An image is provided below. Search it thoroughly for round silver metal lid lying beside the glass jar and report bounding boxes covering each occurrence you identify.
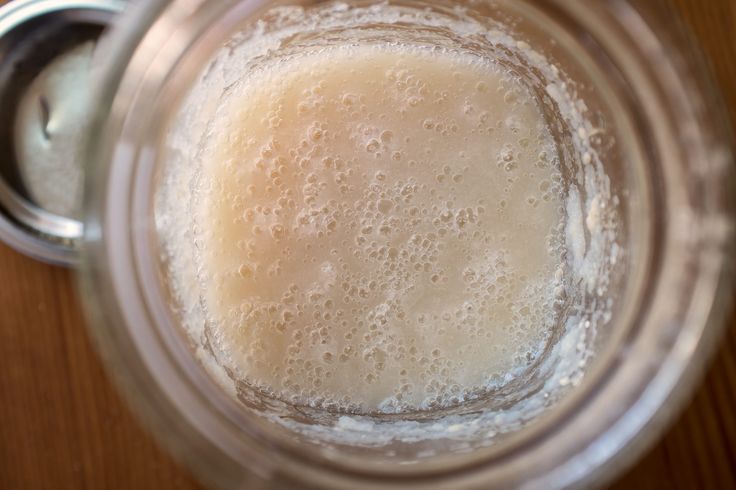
[0,0,125,266]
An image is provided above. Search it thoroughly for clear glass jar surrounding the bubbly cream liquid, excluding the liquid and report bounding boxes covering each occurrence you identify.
[77,0,733,489]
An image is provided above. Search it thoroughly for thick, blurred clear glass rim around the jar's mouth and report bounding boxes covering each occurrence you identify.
[77,2,732,488]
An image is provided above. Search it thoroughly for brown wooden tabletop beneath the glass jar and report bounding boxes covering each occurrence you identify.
[0,0,736,490]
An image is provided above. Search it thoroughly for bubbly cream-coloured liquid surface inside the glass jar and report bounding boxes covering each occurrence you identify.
[194,46,563,411]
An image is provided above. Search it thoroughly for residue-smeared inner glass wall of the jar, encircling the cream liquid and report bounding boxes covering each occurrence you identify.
[142,1,656,472]
